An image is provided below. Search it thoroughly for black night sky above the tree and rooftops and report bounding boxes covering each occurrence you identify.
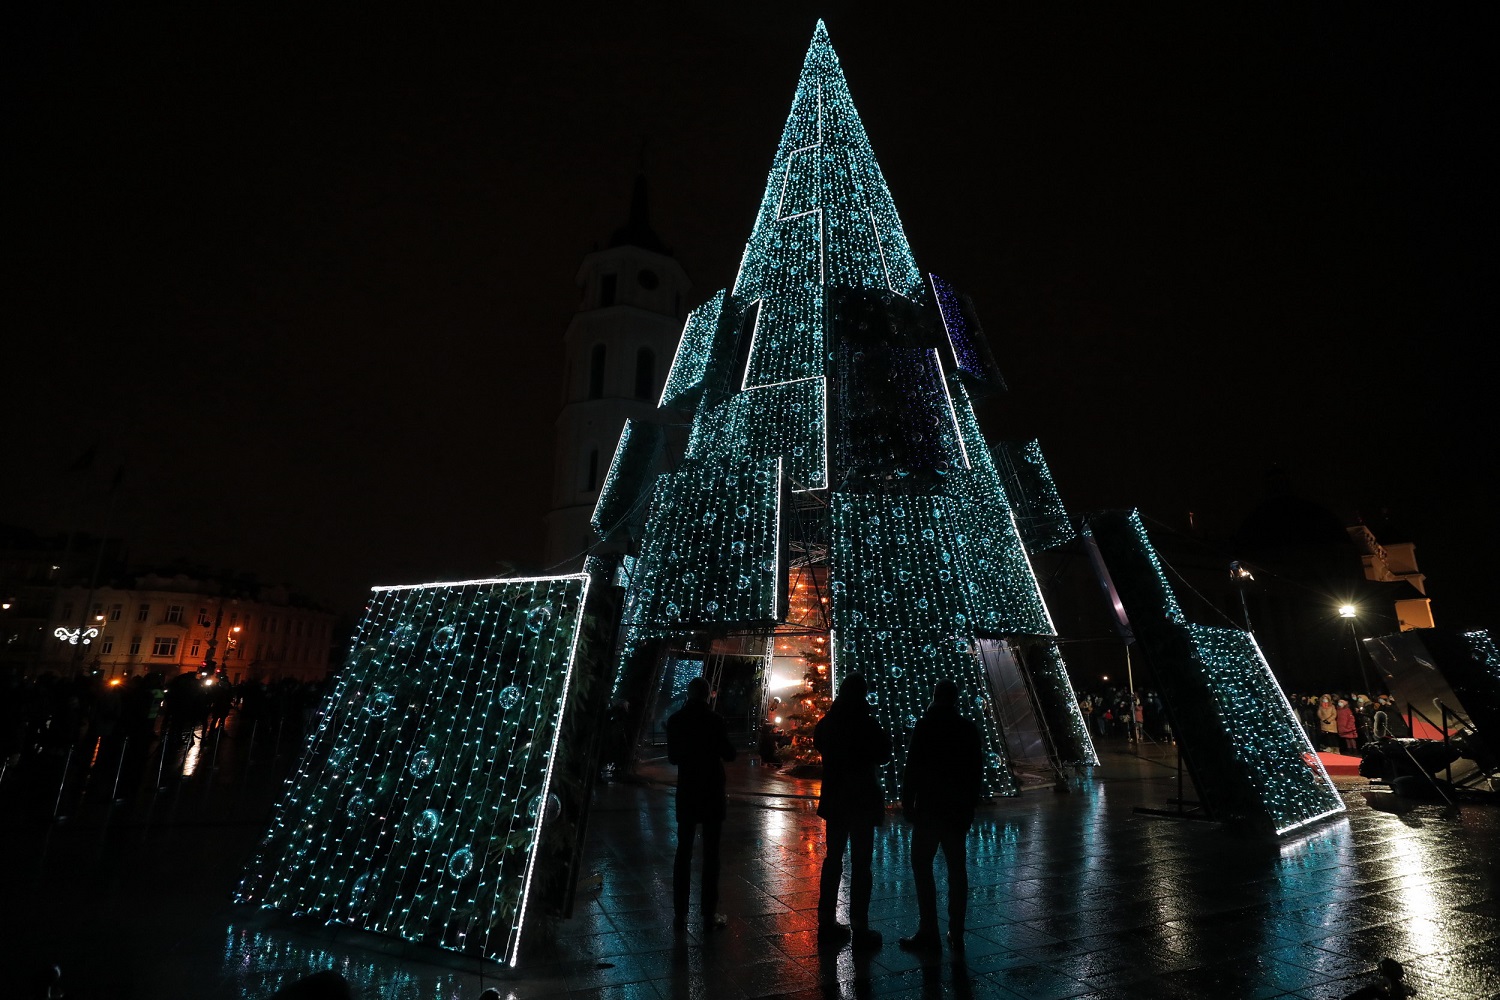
[0,3,1497,625]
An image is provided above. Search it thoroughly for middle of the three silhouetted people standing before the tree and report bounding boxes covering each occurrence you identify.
[813,673,891,951]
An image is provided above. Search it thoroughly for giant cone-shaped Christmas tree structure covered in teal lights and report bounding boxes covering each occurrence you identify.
[594,22,1095,798]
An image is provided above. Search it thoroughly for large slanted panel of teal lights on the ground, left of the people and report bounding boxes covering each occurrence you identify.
[236,576,588,966]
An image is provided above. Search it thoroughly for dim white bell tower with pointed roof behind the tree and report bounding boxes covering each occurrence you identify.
[543,175,690,573]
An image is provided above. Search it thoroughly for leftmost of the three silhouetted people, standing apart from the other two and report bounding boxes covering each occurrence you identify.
[666,678,735,931]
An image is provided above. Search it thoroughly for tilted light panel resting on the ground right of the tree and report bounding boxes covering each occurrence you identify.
[1086,511,1344,835]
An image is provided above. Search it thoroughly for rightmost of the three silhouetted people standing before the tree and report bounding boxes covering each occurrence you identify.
[900,681,984,951]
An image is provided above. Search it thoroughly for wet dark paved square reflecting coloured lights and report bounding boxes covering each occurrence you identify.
[0,728,1500,1000]
